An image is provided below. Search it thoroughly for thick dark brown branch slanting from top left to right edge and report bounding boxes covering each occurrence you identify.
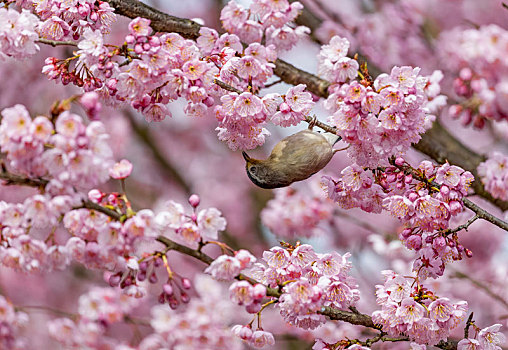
[107,0,508,211]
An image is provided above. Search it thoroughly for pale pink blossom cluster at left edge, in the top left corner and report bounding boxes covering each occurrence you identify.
[0,8,39,60]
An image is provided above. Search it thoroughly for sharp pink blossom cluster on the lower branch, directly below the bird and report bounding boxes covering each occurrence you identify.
[251,244,360,329]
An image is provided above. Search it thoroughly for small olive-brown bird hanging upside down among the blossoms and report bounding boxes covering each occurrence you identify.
[242,127,340,189]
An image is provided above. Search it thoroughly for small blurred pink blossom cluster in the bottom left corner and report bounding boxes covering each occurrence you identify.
[0,295,28,350]
